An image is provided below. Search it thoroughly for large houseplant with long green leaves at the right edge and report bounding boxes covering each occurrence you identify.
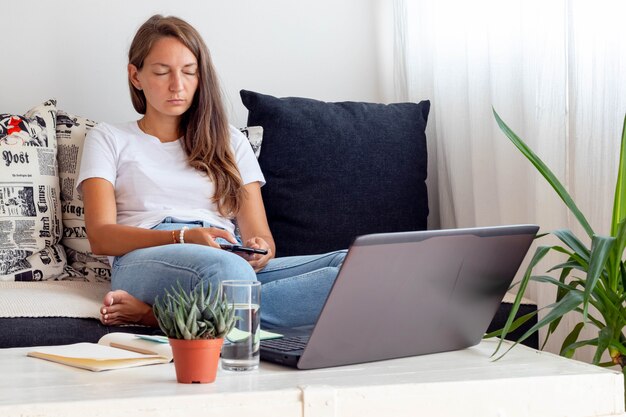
[490,110,626,375]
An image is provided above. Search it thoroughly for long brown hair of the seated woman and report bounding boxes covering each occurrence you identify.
[128,15,244,217]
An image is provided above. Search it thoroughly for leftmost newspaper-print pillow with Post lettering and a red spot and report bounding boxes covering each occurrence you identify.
[0,100,67,281]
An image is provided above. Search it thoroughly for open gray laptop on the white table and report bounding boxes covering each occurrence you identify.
[261,225,539,369]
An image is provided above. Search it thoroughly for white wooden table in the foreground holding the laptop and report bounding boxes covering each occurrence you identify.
[0,341,626,417]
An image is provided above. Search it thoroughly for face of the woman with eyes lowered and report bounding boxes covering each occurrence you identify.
[128,37,198,118]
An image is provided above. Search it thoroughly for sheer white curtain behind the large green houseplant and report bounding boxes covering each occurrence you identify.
[390,0,626,359]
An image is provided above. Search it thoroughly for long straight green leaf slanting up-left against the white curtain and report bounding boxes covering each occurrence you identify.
[492,109,594,237]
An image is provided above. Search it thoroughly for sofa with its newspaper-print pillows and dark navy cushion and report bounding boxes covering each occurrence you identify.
[0,90,538,348]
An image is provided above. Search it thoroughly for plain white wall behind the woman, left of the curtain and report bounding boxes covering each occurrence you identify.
[0,0,382,126]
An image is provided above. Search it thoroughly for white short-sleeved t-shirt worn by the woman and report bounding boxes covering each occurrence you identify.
[76,121,265,233]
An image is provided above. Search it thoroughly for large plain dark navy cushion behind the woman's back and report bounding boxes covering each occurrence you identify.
[241,90,430,256]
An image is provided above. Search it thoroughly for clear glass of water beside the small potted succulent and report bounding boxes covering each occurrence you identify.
[222,281,261,371]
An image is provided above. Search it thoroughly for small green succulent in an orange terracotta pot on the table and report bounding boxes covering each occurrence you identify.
[153,283,235,384]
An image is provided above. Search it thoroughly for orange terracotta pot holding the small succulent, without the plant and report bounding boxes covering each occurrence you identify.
[170,338,224,384]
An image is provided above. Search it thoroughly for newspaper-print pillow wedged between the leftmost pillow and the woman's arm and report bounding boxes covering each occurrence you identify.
[56,110,111,281]
